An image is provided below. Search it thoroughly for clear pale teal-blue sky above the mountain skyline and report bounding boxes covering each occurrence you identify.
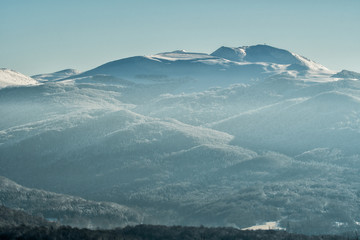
[0,0,360,75]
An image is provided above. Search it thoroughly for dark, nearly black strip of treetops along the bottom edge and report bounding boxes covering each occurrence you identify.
[0,225,357,240]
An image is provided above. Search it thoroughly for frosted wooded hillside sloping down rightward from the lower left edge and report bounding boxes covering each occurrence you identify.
[0,177,141,228]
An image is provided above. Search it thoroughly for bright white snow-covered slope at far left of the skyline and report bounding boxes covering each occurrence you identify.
[0,68,39,88]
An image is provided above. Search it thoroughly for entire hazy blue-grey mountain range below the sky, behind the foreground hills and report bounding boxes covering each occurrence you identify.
[0,45,360,233]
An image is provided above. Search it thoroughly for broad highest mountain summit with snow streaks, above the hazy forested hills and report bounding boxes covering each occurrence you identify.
[67,45,335,91]
